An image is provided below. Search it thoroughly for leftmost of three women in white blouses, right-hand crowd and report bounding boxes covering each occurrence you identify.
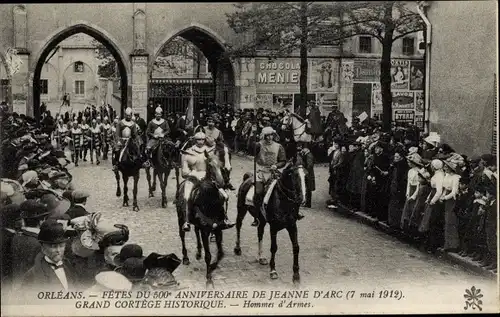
[400,152,422,231]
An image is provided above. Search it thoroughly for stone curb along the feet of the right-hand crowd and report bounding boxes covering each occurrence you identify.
[333,204,497,279]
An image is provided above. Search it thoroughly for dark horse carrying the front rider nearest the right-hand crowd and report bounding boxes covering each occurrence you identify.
[234,162,306,283]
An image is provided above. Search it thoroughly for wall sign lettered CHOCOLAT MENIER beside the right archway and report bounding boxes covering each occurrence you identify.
[255,58,300,92]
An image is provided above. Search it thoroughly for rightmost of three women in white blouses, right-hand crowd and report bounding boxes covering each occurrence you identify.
[440,160,460,252]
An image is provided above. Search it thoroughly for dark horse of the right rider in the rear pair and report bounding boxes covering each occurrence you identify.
[146,138,180,208]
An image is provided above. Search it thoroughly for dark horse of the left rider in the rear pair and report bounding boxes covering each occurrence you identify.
[114,137,143,211]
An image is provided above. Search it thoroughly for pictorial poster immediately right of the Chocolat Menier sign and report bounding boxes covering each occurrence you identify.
[309,59,339,92]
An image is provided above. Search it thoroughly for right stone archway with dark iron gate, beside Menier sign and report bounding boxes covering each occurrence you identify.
[148,23,236,121]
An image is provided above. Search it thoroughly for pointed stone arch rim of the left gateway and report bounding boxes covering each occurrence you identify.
[33,22,130,118]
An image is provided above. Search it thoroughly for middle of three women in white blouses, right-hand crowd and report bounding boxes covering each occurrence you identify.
[419,159,444,252]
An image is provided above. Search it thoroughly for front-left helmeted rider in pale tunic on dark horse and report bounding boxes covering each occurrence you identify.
[182,132,234,231]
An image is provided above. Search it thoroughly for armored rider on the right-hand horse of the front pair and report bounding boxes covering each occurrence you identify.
[252,127,304,227]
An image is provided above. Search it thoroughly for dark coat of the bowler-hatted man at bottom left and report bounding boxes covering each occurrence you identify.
[21,252,78,292]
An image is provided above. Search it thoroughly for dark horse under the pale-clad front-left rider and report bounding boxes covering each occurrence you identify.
[176,152,226,286]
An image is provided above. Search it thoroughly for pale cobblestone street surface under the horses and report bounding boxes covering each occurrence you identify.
[72,157,494,289]
